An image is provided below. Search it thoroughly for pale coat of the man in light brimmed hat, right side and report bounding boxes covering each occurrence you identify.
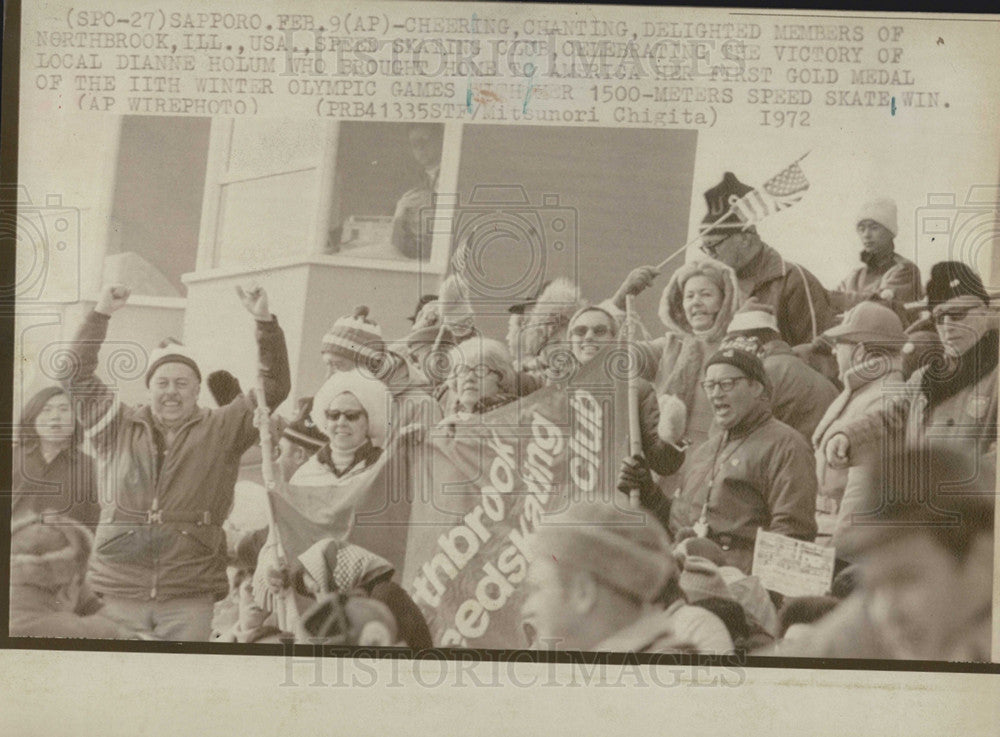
[812,360,903,547]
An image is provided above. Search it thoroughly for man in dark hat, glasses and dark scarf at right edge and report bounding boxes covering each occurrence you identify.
[826,261,1000,480]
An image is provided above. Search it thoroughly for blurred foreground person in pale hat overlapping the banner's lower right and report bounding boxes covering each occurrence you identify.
[521,502,733,655]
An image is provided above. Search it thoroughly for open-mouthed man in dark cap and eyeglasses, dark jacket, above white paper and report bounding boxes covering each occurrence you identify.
[670,348,816,573]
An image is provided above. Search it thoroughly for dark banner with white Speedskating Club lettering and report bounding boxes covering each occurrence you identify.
[403,348,628,648]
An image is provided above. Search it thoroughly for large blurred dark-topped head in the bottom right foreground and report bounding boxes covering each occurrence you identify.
[838,450,995,660]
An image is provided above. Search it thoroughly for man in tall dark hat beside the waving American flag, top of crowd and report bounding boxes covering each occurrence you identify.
[701,172,835,346]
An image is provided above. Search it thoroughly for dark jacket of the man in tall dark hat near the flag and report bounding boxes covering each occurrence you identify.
[737,244,836,346]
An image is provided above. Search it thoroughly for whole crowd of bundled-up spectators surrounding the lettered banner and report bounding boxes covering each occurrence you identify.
[10,173,1000,660]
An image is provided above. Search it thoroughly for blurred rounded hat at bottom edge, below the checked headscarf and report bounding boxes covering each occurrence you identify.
[295,593,399,647]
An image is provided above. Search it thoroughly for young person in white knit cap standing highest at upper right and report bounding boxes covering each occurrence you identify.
[830,198,924,312]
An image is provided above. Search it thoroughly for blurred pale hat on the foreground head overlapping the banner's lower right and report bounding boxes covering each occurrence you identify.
[529,501,677,602]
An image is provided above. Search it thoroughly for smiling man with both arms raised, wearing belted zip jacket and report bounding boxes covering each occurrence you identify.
[63,285,290,641]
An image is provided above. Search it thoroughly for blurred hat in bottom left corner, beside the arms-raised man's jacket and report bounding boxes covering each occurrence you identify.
[10,515,94,589]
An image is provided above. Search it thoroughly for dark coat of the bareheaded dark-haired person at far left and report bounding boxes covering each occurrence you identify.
[11,442,101,532]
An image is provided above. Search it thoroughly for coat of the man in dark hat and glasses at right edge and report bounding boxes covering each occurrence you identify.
[841,330,1000,478]
